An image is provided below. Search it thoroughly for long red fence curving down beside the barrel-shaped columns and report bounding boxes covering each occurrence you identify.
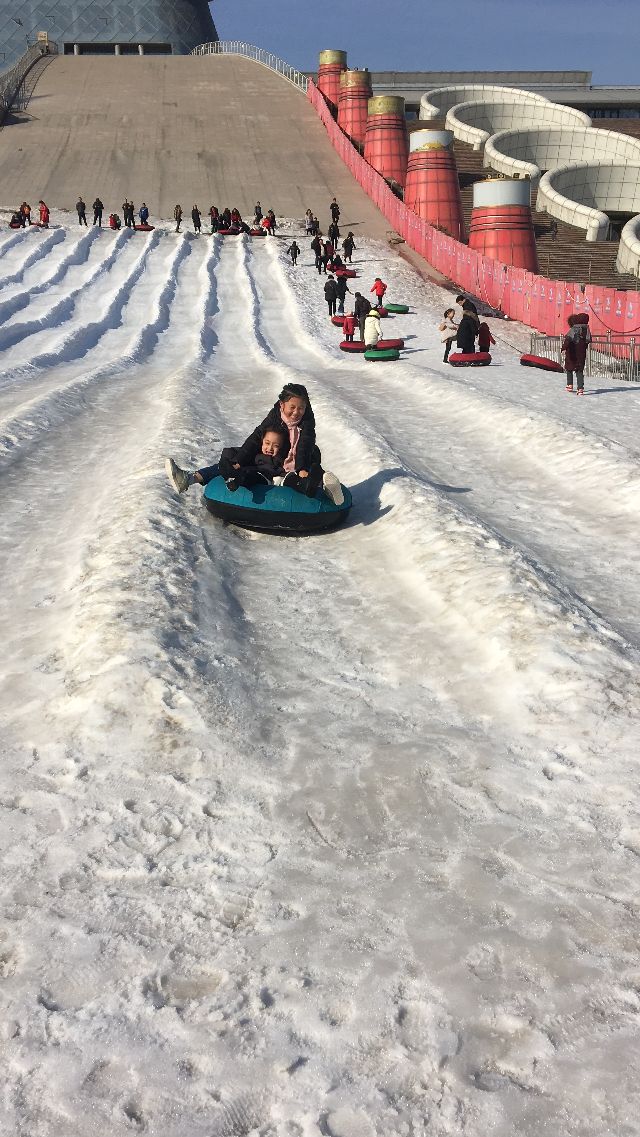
[307,80,640,335]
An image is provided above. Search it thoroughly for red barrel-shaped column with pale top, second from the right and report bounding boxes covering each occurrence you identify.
[405,131,465,241]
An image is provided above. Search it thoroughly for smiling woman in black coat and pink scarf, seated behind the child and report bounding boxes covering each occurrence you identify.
[165,383,344,505]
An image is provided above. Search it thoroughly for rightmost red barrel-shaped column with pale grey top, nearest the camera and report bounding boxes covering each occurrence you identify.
[468,177,538,273]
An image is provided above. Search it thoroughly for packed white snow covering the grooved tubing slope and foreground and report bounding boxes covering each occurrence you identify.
[0,215,640,1137]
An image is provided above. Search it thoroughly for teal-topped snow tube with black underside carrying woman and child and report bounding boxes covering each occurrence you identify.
[205,474,351,537]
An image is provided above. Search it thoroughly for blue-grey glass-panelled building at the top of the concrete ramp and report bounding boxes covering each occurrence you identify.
[0,0,218,73]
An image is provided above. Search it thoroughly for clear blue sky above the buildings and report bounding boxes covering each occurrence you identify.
[211,0,640,85]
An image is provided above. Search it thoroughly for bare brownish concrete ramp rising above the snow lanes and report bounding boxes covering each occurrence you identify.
[0,56,389,235]
